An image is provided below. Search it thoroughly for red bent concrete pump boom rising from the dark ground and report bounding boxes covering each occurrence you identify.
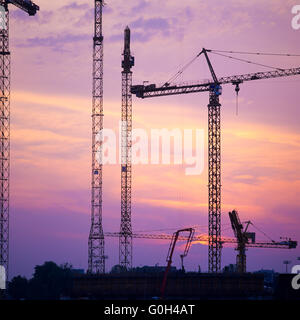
[160,228,195,299]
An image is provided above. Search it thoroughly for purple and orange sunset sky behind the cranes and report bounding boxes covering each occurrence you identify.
[6,0,300,276]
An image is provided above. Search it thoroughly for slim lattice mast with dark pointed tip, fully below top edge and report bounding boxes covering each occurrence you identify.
[119,27,134,270]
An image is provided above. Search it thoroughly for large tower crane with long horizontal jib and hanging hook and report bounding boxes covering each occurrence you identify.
[131,48,300,273]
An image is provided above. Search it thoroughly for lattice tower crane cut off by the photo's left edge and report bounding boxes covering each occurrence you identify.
[0,0,39,273]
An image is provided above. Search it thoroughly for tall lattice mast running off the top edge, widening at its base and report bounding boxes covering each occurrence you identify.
[88,0,105,273]
